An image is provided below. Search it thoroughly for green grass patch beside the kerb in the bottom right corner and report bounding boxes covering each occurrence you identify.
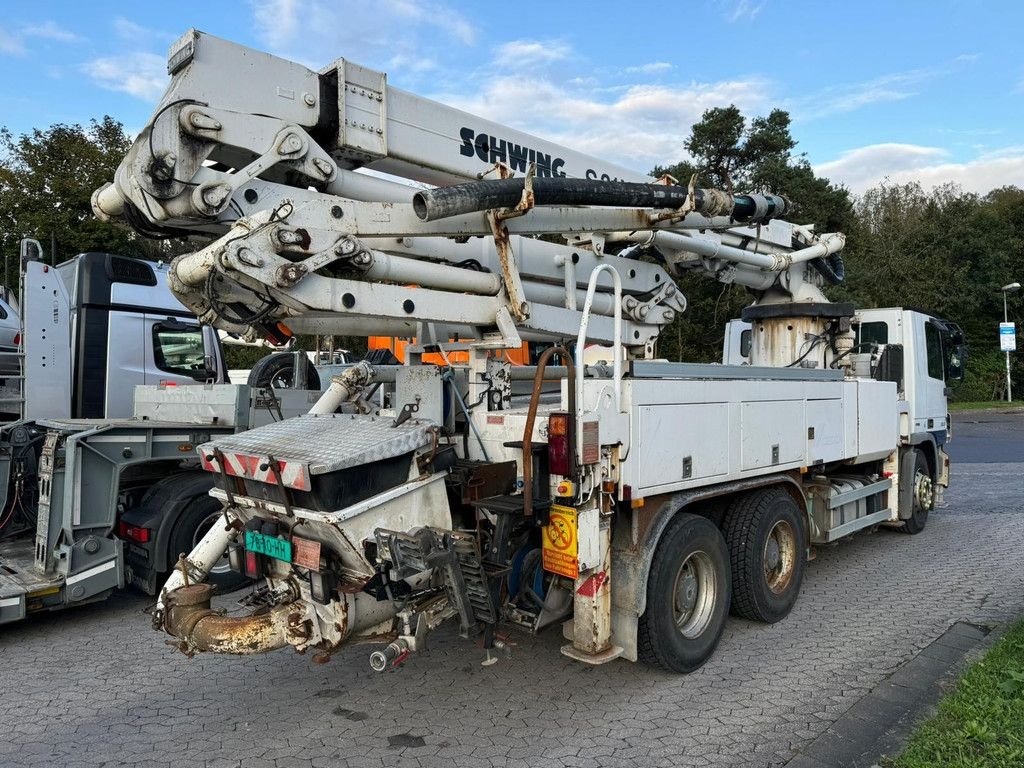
[884,621,1024,768]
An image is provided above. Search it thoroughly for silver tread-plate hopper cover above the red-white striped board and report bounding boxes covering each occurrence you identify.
[200,414,433,475]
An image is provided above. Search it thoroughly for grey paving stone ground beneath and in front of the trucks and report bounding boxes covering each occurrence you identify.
[0,442,1024,768]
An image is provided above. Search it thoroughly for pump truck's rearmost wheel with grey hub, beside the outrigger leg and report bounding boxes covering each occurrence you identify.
[637,512,729,673]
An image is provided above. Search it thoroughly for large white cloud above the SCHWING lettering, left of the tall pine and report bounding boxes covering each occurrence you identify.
[439,76,767,173]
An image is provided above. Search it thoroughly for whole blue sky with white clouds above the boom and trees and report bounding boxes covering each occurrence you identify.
[0,0,1024,191]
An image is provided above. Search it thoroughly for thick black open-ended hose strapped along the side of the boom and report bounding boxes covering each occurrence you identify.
[413,178,792,223]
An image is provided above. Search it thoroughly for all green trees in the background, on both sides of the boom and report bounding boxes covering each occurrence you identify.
[0,115,1024,400]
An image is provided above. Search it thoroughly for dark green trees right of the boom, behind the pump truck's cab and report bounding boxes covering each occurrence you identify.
[652,106,1024,400]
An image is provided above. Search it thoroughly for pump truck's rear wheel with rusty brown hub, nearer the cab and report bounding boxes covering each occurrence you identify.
[725,487,807,624]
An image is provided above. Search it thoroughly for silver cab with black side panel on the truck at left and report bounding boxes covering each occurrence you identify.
[16,253,227,420]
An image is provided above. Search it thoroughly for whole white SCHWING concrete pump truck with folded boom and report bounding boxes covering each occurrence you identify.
[93,31,963,672]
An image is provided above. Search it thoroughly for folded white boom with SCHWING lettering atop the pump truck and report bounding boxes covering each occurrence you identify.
[93,30,843,356]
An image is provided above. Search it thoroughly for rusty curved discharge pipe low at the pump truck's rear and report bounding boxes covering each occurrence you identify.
[164,584,309,656]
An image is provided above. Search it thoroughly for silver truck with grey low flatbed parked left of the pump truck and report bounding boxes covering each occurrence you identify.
[0,241,318,624]
